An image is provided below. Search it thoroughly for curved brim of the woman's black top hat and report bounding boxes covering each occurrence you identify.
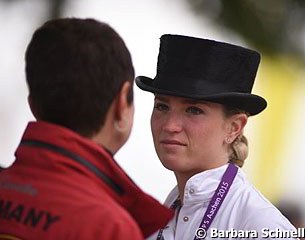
[135,76,267,116]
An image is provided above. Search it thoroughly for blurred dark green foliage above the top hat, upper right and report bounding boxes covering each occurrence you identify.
[187,0,305,58]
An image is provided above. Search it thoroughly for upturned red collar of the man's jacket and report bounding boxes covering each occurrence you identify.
[16,121,173,237]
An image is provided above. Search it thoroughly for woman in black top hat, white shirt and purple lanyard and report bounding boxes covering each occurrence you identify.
[136,35,297,240]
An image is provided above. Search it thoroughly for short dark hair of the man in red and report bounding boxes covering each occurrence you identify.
[25,18,134,137]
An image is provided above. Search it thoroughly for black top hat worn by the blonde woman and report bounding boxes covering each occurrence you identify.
[136,34,267,115]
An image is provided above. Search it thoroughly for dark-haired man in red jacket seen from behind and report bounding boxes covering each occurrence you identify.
[0,18,172,240]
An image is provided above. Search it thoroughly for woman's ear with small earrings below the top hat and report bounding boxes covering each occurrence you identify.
[228,113,248,141]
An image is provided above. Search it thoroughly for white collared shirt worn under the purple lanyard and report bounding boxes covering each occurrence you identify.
[148,164,296,240]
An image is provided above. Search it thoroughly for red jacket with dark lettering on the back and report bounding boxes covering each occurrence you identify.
[0,121,172,240]
